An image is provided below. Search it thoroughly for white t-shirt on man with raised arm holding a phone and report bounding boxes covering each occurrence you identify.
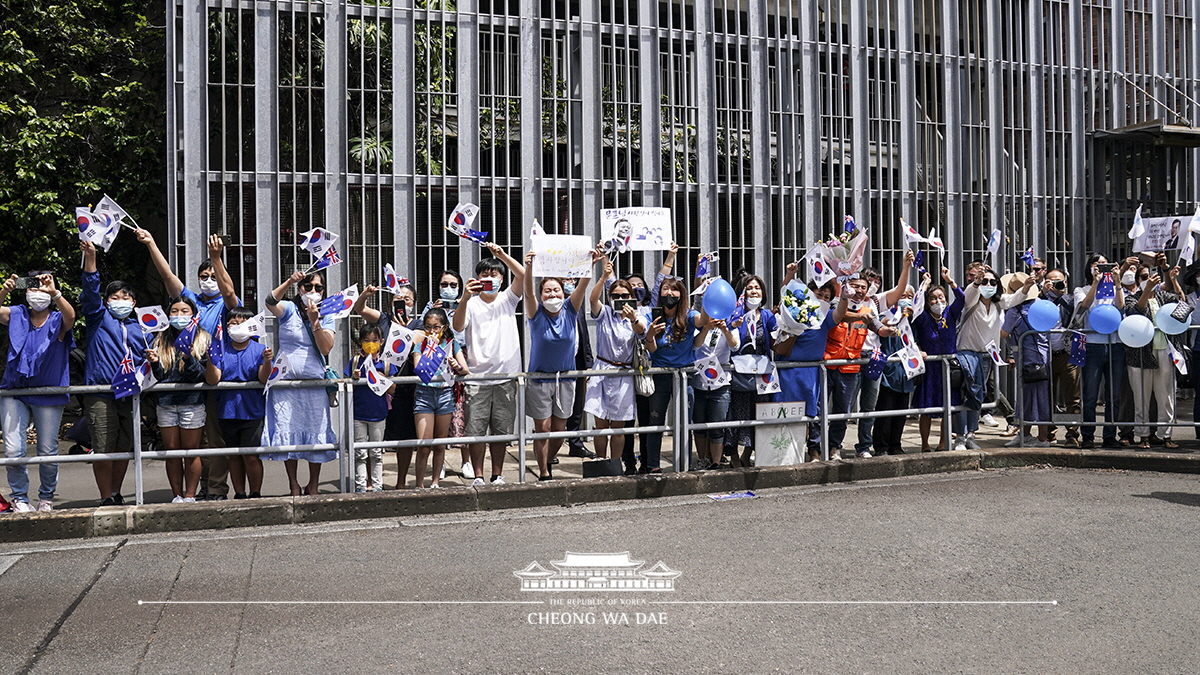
[458,287,521,384]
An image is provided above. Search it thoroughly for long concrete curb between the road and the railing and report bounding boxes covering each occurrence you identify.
[0,448,1200,542]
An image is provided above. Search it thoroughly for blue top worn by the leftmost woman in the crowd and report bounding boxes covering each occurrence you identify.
[0,305,74,406]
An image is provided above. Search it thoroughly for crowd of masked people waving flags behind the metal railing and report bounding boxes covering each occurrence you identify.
[0,229,1200,512]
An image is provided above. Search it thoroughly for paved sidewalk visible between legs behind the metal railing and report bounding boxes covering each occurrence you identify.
[4,401,1200,509]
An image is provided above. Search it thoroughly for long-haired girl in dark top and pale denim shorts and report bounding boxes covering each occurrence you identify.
[145,298,211,503]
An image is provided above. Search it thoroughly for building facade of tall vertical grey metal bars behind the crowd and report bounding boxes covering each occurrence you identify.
[167,0,1200,324]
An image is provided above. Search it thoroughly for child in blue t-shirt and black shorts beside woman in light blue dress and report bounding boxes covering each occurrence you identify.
[204,307,274,500]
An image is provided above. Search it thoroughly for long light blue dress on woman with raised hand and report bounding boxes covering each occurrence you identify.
[262,300,337,464]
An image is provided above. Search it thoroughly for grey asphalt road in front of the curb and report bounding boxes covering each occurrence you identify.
[0,468,1200,675]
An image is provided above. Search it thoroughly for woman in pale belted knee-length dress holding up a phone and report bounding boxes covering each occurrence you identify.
[583,259,646,459]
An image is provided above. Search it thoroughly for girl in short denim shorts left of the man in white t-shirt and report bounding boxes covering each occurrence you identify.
[412,307,468,489]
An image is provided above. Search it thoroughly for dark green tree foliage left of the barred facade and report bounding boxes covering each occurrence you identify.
[0,0,166,286]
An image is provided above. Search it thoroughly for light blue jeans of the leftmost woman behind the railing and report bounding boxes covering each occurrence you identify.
[0,396,64,502]
